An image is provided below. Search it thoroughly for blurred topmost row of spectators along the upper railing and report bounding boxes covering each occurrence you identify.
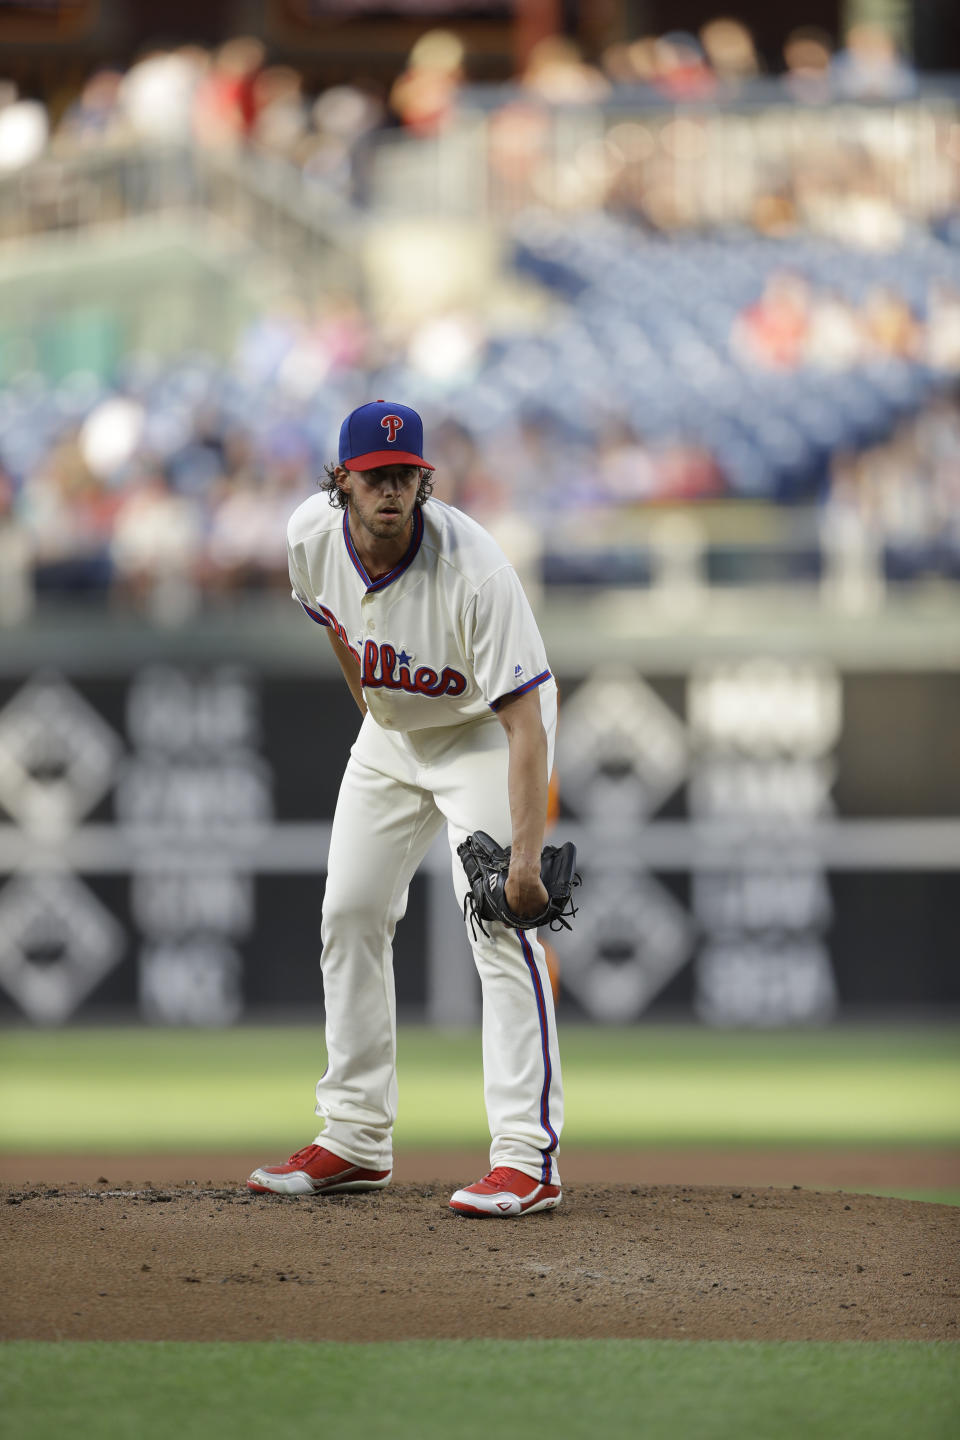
[0,17,917,181]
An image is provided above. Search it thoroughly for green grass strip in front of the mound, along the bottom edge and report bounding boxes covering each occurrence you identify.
[0,1341,960,1440]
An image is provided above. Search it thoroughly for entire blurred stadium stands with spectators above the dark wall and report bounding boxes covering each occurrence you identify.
[0,16,960,621]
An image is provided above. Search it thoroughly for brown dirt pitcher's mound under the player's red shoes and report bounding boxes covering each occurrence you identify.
[0,1181,960,1341]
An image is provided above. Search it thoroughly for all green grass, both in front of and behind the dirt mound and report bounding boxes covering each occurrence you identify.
[0,1027,960,1440]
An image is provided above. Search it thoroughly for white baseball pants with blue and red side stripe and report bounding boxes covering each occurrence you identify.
[317,681,563,1184]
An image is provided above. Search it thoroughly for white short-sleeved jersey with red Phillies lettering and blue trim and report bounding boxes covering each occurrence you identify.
[288,492,551,732]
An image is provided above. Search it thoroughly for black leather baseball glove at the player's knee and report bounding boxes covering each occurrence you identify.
[456,829,580,936]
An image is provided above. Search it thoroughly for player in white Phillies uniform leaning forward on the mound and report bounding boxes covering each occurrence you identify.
[248,400,563,1217]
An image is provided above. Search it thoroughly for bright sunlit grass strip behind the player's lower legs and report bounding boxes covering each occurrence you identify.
[0,1025,960,1152]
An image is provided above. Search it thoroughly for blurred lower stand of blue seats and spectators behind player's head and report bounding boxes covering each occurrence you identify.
[0,204,960,622]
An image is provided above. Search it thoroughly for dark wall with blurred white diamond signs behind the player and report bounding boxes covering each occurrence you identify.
[0,631,960,1025]
